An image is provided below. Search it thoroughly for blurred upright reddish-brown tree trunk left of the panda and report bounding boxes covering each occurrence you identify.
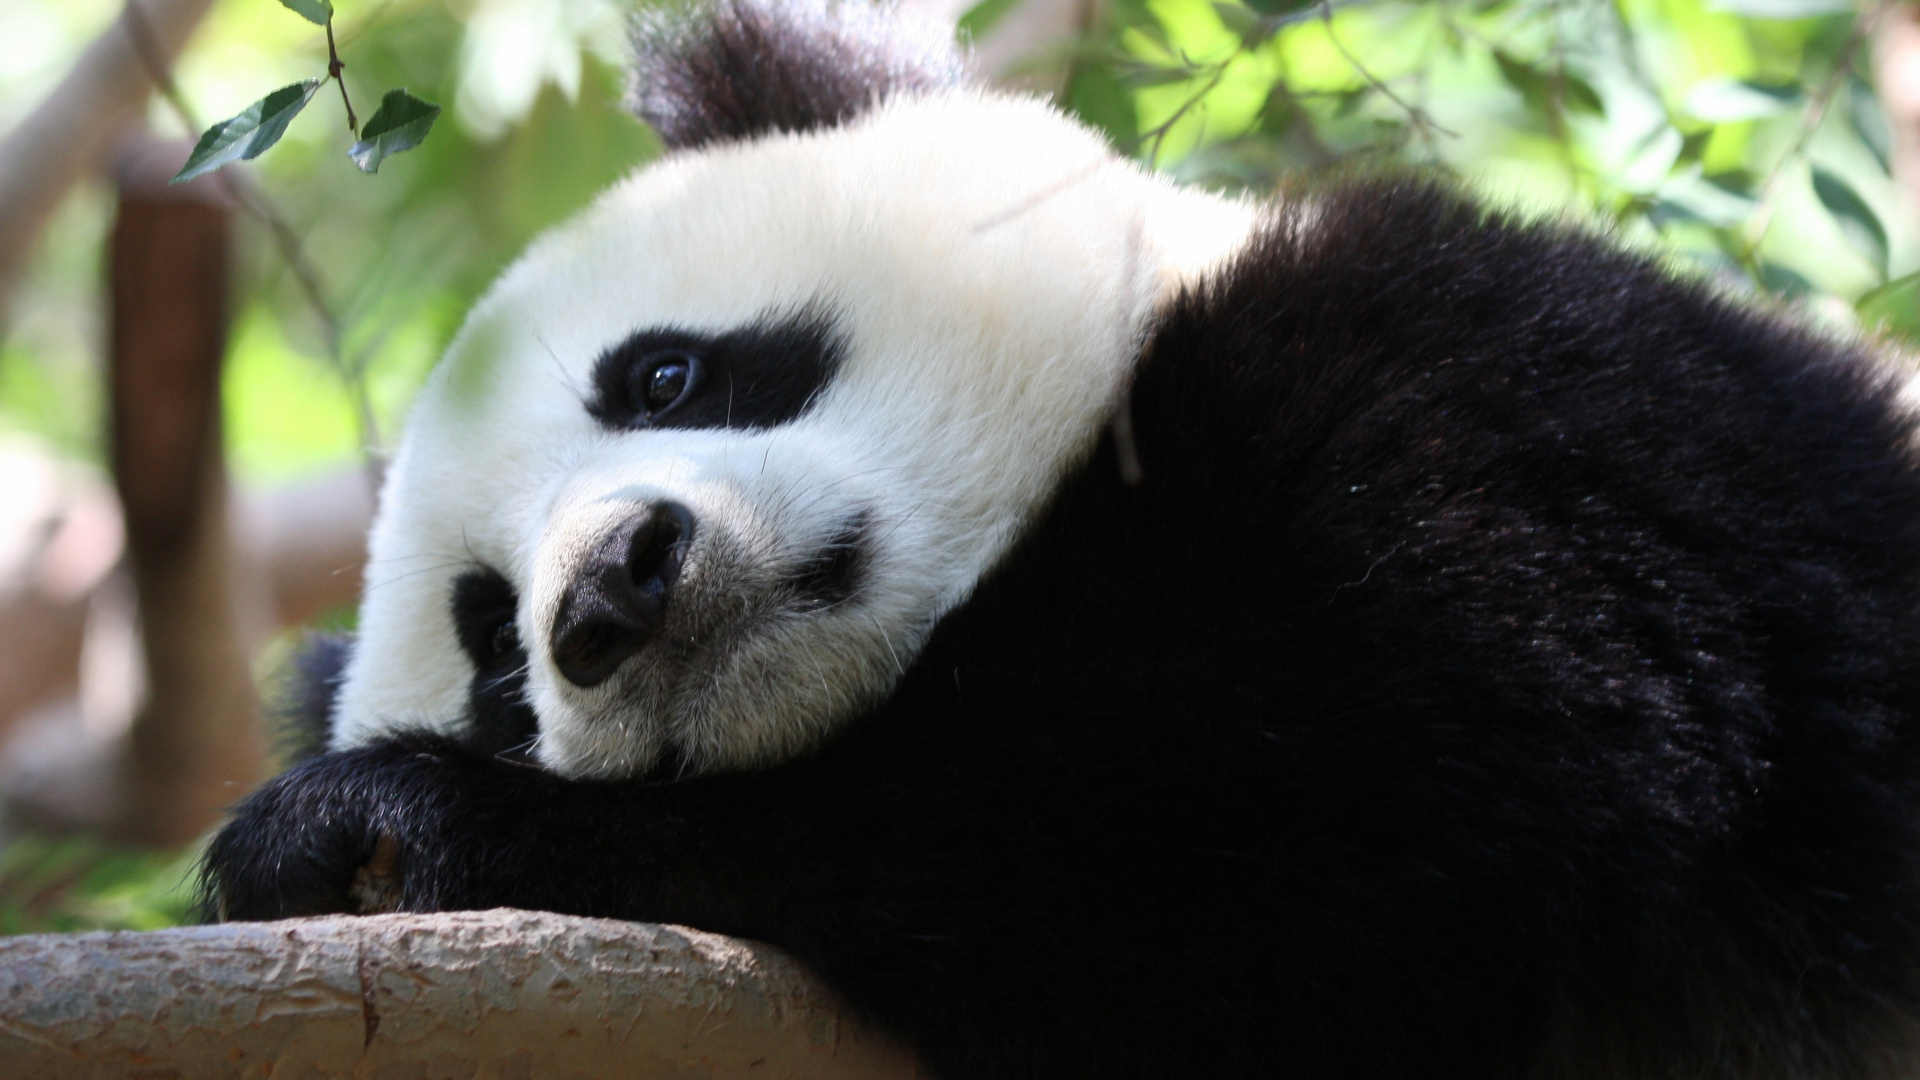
[108,138,265,846]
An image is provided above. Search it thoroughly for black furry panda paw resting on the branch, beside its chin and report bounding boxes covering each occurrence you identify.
[200,740,472,920]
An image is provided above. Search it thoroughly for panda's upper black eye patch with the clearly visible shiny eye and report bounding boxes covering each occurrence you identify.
[588,307,843,430]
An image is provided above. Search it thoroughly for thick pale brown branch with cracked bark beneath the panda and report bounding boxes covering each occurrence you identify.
[0,909,924,1080]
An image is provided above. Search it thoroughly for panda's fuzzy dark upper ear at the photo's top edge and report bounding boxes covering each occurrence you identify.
[632,0,968,150]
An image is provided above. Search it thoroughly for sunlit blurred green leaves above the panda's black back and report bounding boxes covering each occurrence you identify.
[1036,0,1920,331]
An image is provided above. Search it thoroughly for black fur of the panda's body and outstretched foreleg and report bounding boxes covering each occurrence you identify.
[207,181,1920,1080]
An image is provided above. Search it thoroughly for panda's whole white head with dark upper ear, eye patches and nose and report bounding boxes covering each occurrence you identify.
[332,0,1254,776]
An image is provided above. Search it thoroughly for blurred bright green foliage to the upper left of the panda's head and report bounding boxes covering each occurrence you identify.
[0,0,659,484]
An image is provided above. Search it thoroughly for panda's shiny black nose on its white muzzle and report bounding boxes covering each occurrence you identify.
[549,502,693,686]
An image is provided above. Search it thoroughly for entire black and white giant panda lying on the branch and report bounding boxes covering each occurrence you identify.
[205,0,1920,1080]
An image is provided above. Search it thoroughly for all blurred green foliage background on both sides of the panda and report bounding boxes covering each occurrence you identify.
[0,0,1920,932]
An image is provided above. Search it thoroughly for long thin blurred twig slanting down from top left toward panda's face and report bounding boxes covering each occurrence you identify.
[127,0,380,470]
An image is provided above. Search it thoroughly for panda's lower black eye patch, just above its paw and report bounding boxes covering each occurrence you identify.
[451,567,540,757]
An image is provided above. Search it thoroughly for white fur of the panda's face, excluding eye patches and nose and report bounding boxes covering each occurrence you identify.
[334,84,1254,776]
